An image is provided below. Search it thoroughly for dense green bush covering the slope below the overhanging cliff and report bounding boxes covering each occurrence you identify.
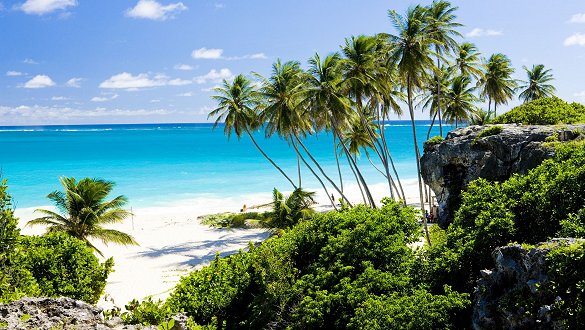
[427,143,585,292]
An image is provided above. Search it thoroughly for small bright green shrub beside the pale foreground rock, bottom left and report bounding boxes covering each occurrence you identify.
[121,297,172,325]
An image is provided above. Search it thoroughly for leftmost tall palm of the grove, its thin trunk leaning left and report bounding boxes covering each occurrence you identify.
[207,74,297,189]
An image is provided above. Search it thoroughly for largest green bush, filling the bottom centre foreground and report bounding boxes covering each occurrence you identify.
[162,200,469,329]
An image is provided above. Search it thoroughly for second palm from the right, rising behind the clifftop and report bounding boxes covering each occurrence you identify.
[479,54,516,117]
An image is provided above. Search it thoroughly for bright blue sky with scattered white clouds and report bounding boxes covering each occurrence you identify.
[0,0,585,125]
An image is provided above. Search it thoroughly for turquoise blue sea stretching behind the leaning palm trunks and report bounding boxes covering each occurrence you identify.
[0,121,453,208]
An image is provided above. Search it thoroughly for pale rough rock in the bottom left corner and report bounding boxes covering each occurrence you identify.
[0,297,187,330]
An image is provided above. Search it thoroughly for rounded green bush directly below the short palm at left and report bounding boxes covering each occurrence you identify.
[19,233,114,304]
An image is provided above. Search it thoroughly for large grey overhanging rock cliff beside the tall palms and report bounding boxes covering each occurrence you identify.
[421,124,585,228]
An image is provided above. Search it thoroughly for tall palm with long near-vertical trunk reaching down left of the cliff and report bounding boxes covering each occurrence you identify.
[388,6,436,244]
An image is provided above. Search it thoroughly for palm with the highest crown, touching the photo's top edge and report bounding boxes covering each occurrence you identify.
[427,0,462,136]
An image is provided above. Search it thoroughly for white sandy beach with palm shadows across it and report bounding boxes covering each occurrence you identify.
[16,180,418,308]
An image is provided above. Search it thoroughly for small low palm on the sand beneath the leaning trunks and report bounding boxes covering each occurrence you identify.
[270,188,315,228]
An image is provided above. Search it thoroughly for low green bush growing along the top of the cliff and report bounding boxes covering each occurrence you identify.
[492,97,585,125]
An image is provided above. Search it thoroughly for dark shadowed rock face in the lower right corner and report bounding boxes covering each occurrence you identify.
[472,238,582,330]
